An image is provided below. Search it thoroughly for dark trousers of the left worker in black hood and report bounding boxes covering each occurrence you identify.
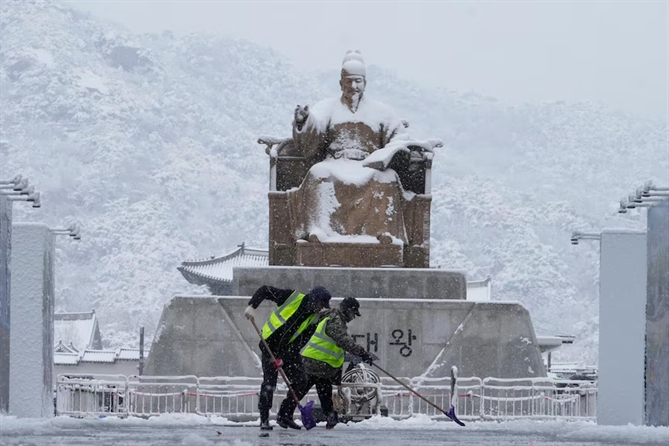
[258,345,306,420]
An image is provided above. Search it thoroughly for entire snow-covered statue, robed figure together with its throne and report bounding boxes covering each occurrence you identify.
[259,51,441,267]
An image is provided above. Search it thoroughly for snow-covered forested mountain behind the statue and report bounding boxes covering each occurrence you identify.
[0,1,669,362]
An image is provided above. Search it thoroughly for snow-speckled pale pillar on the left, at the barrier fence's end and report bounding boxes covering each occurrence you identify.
[9,223,54,418]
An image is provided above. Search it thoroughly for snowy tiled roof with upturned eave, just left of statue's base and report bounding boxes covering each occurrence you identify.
[177,243,269,285]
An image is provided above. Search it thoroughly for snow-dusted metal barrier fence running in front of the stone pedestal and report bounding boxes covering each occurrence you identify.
[56,375,597,421]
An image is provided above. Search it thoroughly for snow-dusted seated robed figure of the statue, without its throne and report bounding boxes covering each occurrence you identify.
[259,51,441,266]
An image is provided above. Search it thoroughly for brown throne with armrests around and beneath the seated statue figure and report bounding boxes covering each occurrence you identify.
[258,132,434,268]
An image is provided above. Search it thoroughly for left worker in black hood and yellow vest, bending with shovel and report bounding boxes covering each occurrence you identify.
[244,285,332,430]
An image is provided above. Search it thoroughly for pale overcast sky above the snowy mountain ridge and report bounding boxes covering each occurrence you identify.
[63,0,669,117]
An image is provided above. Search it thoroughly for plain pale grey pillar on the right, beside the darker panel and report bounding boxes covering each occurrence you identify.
[597,229,647,425]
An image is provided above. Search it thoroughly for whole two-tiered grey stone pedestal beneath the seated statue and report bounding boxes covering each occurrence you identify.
[146,266,546,378]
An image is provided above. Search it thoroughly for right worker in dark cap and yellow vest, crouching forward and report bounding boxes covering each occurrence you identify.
[278,297,378,429]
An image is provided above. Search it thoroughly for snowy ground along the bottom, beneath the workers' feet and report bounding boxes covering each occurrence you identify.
[0,415,669,446]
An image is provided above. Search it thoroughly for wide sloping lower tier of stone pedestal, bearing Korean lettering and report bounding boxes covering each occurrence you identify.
[145,296,546,378]
